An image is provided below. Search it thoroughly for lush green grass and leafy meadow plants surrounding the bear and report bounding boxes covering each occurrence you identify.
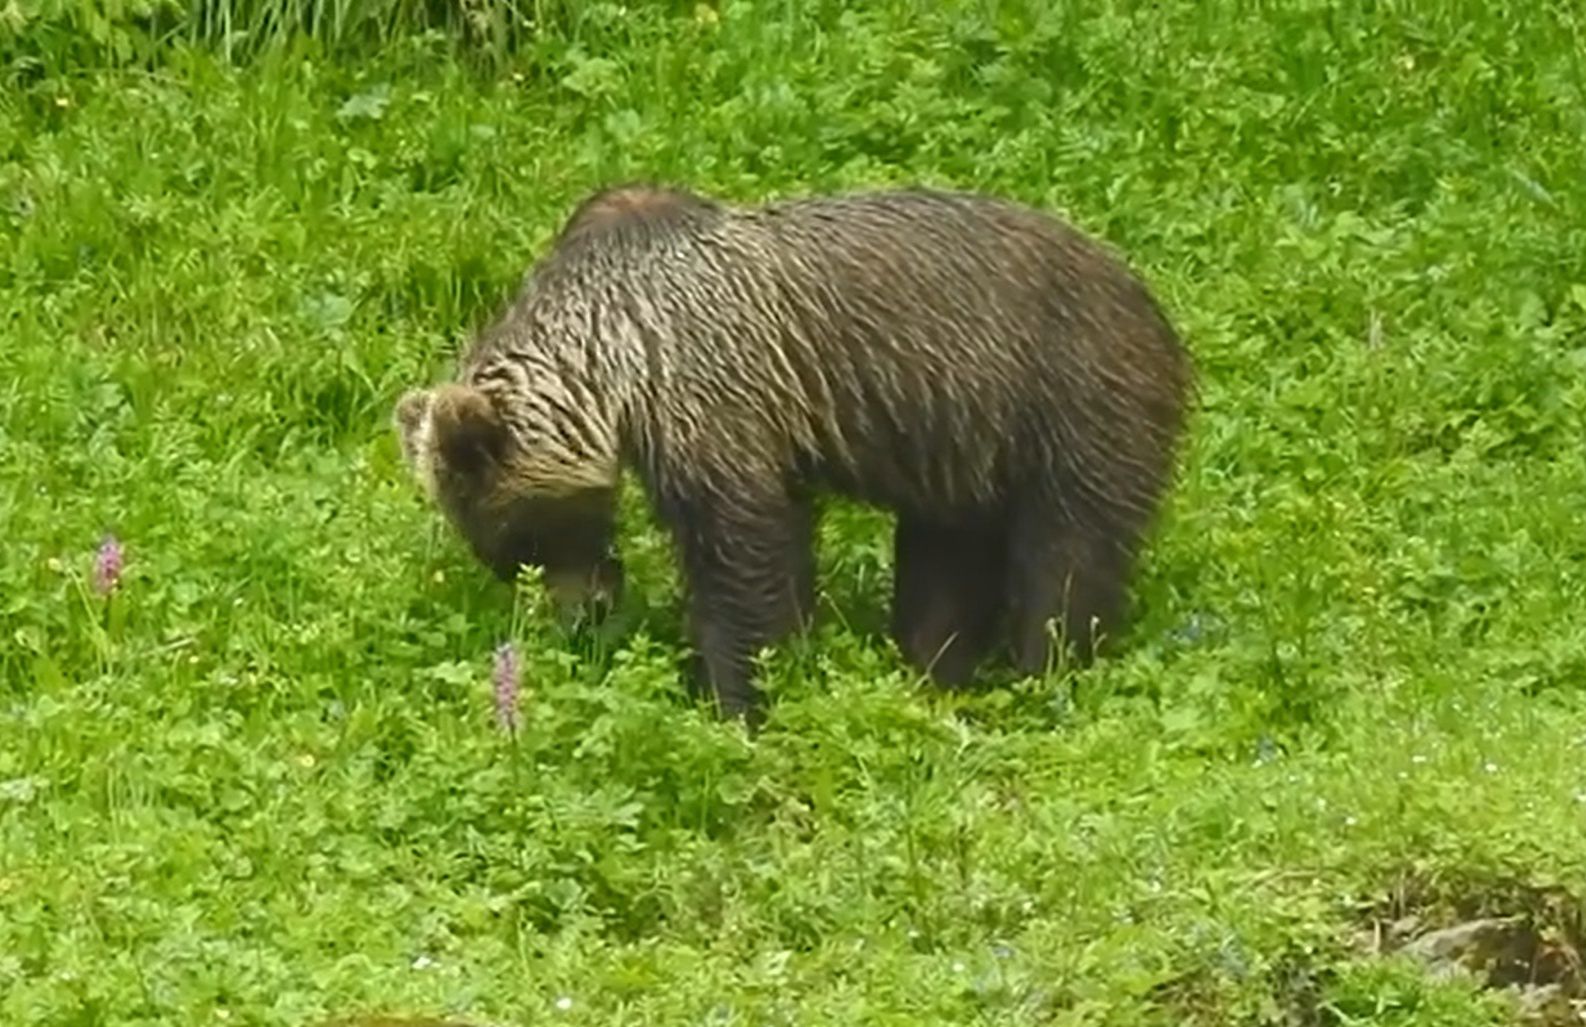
[0,0,1586,1025]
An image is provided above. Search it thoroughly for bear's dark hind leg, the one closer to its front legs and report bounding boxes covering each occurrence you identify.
[891,515,1007,686]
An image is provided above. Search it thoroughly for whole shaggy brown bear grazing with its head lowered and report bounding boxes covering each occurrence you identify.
[398,178,1193,713]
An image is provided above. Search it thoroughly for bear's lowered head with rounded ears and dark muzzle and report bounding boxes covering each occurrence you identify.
[395,384,623,613]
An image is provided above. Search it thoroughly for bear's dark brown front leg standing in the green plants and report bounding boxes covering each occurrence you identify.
[671,488,814,724]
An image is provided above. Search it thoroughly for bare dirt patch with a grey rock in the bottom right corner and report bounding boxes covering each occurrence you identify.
[1354,873,1586,1027]
